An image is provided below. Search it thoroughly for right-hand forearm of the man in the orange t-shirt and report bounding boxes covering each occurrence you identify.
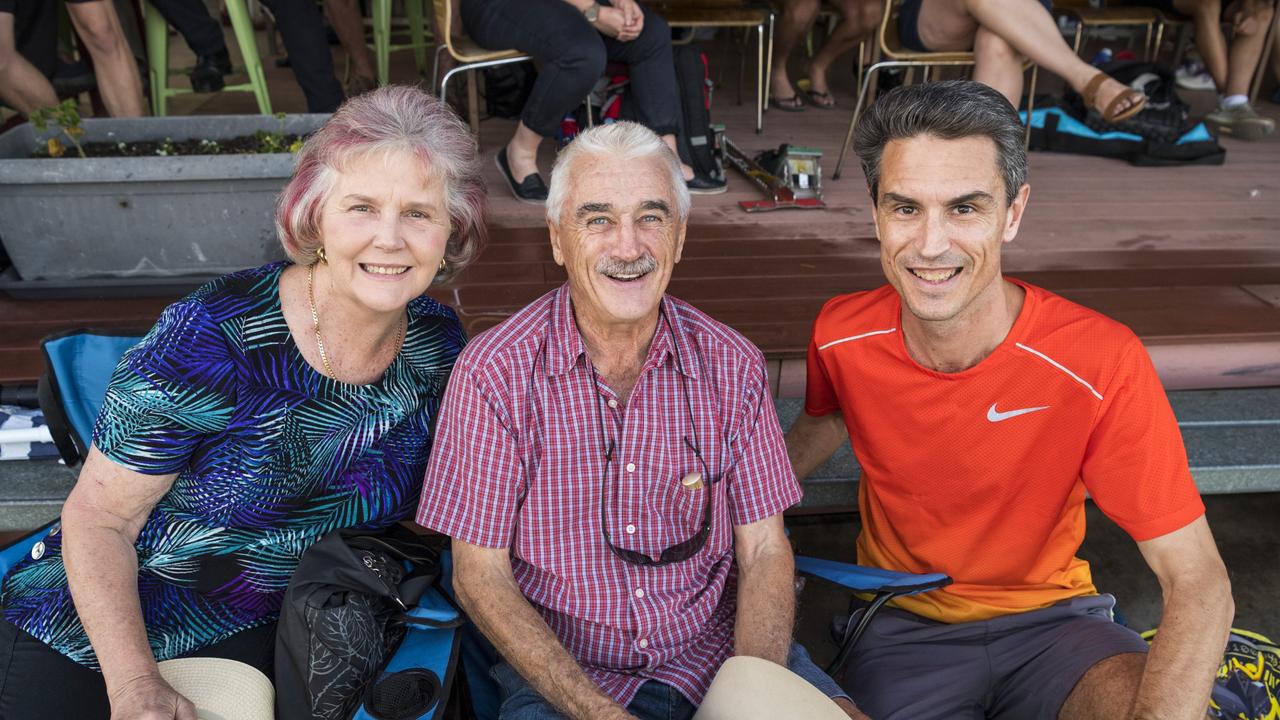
[1133,515,1235,720]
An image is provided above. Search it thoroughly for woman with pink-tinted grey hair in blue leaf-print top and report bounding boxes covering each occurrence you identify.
[0,87,485,719]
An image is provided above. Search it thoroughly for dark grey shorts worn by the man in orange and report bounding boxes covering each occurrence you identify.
[841,594,1147,720]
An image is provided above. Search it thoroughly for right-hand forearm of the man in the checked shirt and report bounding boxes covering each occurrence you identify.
[733,540,796,667]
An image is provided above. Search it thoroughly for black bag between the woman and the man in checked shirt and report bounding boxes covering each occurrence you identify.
[275,525,463,720]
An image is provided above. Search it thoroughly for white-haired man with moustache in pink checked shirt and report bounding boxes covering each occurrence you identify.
[417,123,852,720]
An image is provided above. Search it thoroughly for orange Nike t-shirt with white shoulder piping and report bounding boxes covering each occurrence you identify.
[805,281,1204,623]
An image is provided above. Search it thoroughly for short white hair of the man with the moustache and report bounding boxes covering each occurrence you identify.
[547,122,690,227]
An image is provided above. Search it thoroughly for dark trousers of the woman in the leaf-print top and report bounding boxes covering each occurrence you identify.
[0,620,275,720]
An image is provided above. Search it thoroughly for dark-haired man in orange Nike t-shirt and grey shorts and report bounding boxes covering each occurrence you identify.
[787,81,1233,720]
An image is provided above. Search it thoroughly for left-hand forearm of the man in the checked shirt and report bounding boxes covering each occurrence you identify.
[456,561,628,719]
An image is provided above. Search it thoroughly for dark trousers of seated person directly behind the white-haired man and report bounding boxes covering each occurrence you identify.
[462,0,680,137]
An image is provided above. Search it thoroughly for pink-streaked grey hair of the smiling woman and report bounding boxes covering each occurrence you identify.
[275,85,488,284]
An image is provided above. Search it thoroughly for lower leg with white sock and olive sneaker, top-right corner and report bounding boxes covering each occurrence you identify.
[1204,0,1276,140]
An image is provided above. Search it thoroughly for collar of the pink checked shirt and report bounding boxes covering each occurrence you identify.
[547,283,699,379]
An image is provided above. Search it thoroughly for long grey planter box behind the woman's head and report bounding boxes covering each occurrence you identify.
[0,115,328,282]
